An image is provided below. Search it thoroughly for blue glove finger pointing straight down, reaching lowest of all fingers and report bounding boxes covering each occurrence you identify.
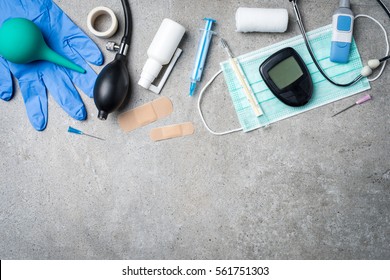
[19,77,48,131]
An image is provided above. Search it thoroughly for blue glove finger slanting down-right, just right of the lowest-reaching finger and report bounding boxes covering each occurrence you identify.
[43,64,87,121]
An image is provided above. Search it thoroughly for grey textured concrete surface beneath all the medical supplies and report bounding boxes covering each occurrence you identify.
[0,0,390,259]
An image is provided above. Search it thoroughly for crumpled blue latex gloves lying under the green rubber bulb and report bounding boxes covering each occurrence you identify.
[0,0,103,131]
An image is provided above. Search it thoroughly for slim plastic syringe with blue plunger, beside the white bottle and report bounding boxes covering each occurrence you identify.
[190,18,217,96]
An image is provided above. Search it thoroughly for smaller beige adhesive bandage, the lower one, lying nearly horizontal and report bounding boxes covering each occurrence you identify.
[150,122,195,141]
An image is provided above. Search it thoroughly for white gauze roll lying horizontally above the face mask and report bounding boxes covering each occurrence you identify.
[236,8,288,33]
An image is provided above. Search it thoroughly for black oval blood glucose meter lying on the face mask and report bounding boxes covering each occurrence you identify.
[259,48,313,107]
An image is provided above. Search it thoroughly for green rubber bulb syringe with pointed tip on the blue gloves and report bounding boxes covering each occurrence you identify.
[0,18,85,73]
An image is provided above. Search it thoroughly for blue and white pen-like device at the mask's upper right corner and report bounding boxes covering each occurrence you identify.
[330,0,354,63]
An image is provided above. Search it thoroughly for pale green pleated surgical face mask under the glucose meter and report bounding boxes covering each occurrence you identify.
[202,25,371,134]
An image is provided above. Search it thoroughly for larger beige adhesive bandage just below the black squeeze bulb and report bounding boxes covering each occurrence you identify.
[118,97,173,132]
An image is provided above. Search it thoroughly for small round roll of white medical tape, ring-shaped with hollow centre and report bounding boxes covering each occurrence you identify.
[87,6,118,39]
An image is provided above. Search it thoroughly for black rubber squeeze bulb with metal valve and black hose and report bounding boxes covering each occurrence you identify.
[93,0,132,120]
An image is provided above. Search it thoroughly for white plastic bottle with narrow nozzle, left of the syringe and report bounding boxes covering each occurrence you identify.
[138,18,186,89]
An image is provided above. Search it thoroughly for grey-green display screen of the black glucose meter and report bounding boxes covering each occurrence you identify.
[268,56,303,90]
